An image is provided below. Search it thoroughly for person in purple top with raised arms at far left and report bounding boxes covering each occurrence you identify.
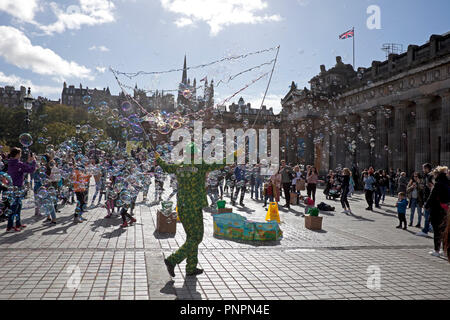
[6,148,36,232]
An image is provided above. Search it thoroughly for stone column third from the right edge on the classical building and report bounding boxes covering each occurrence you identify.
[393,103,408,171]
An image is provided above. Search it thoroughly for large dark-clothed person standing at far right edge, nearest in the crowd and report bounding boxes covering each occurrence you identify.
[425,167,450,257]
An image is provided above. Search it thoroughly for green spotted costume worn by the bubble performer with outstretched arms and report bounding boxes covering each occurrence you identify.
[156,157,226,273]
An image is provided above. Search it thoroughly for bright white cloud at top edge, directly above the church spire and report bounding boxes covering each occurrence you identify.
[160,0,281,36]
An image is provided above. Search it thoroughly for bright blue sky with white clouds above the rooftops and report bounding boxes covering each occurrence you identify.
[0,0,450,111]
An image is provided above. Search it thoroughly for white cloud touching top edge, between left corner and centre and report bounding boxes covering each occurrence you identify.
[40,0,115,35]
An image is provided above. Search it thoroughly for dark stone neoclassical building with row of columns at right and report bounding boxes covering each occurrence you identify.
[280,33,450,174]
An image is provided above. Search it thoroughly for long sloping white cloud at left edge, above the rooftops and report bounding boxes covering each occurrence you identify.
[0,26,93,79]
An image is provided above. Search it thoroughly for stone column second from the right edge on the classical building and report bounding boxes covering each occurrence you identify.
[414,97,431,172]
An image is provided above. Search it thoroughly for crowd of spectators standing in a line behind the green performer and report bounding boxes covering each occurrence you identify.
[0,148,449,255]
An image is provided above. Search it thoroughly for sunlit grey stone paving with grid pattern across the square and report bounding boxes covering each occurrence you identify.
[0,181,450,300]
